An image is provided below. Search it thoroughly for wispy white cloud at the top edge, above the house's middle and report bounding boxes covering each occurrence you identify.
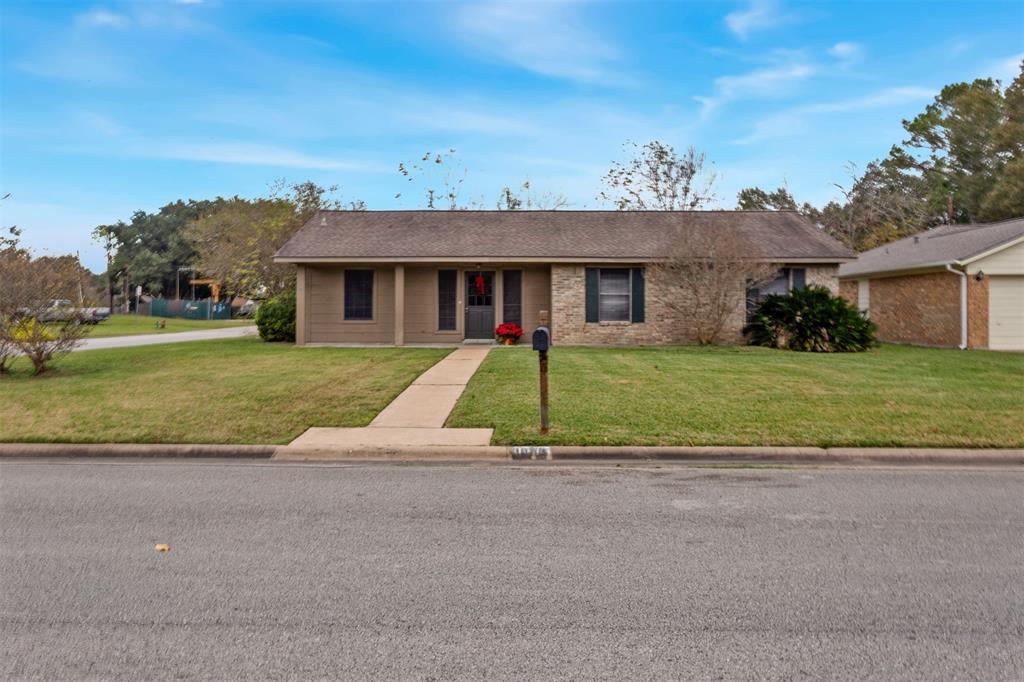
[454,0,622,82]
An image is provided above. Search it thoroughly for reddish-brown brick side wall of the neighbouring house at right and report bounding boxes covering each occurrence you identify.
[840,271,988,348]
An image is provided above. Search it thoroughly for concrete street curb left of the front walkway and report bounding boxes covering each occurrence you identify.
[0,442,279,459]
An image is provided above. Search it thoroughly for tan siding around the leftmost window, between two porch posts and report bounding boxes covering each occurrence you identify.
[305,265,394,343]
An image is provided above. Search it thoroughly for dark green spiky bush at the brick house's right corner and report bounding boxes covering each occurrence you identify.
[743,287,877,353]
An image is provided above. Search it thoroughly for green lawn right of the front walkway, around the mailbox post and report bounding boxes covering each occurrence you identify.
[449,345,1024,447]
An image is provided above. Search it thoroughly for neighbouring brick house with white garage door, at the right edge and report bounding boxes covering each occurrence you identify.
[840,218,1024,350]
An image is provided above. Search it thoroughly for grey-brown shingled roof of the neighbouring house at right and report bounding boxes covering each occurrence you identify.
[839,218,1024,278]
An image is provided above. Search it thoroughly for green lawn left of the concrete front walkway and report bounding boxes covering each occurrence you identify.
[0,338,449,443]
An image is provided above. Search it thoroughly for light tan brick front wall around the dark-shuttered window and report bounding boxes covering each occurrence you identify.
[551,264,839,345]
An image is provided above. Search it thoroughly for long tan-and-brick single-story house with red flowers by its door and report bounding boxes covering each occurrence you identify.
[274,211,855,345]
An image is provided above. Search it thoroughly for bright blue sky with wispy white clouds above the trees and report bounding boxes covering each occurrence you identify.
[0,0,1024,269]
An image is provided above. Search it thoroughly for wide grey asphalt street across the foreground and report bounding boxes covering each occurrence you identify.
[0,461,1024,680]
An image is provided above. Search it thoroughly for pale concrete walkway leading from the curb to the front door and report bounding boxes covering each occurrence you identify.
[274,346,494,459]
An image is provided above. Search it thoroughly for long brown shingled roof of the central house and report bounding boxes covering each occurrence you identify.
[275,211,855,262]
